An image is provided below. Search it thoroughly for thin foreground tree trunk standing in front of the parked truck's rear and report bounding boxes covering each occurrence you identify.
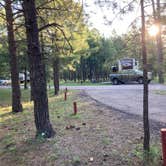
[141,0,150,152]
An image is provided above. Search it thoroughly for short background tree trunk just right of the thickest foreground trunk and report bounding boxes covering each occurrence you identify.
[53,57,59,95]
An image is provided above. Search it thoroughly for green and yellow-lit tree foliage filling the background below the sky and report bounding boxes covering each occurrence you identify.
[0,0,166,80]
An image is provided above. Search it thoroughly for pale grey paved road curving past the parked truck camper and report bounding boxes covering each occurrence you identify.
[60,84,166,122]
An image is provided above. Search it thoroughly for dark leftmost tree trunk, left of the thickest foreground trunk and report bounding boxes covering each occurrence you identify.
[5,0,23,113]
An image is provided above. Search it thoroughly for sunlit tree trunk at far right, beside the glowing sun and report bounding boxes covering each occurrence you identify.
[156,0,164,83]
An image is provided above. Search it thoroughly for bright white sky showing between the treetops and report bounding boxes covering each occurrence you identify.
[84,0,140,37]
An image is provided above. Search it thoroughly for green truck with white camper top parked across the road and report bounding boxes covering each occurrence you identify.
[109,58,152,85]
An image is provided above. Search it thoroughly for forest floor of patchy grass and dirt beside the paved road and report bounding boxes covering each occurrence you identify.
[0,91,162,166]
